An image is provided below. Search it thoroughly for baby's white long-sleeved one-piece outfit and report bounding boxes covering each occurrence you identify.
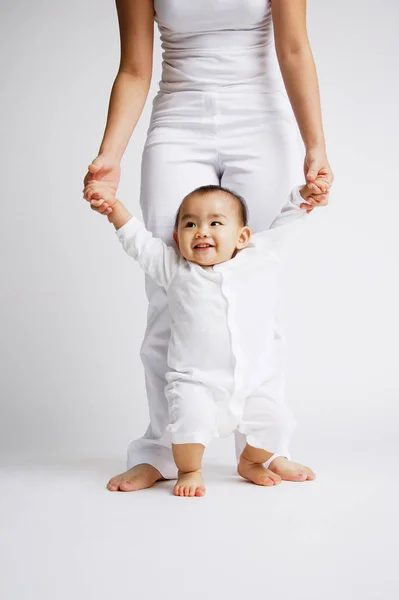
[116,187,307,454]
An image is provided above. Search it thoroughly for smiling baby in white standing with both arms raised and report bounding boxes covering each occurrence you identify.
[86,181,322,496]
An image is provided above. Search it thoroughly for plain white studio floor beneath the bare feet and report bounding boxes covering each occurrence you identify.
[0,443,399,600]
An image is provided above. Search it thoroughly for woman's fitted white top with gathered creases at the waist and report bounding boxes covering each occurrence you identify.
[154,0,284,92]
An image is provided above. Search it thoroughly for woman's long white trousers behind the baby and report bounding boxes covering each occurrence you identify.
[128,91,303,479]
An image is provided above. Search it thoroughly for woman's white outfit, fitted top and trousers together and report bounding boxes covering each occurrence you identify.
[127,0,303,479]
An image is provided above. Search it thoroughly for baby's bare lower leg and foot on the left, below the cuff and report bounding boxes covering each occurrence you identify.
[172,444,205,496]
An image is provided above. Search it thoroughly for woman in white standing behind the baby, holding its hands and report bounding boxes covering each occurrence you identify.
[84,0,333,491]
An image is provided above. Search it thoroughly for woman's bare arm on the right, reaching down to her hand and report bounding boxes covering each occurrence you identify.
[272,0,333,191]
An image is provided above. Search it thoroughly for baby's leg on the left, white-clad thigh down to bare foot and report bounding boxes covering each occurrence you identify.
[165,380,218,496]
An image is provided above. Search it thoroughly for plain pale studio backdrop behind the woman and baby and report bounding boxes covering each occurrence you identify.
[0,0,399,464]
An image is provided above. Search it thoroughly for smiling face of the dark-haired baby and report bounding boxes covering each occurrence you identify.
[173,190,251,266]
